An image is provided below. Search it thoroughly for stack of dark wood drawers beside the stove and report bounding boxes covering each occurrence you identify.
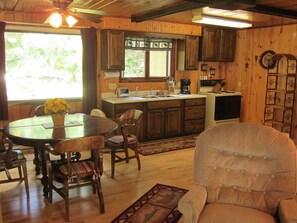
[184,98,205,135]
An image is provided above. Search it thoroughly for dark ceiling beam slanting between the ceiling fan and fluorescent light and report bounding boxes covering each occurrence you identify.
[131,1,208,22]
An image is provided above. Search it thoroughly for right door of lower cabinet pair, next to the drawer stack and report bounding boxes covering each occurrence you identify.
[165,108,182,136]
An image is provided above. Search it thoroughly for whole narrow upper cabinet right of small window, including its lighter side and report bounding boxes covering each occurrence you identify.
[177,36,199,70]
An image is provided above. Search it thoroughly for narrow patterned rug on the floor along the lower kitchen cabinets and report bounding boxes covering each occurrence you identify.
[138,136,197,156]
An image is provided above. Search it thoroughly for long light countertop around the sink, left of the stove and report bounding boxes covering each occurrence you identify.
[102,94,206,104]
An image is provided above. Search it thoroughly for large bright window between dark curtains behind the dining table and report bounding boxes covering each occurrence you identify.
[5,31,82,101]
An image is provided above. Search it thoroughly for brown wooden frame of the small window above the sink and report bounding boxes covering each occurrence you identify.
[119,41,176,83]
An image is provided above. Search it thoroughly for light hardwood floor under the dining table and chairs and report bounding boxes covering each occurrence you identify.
[0,145,194,223]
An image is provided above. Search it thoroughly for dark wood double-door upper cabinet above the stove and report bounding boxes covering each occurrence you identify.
[199,27,236,62]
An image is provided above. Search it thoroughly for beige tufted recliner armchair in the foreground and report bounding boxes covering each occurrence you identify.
[178,123,297,223]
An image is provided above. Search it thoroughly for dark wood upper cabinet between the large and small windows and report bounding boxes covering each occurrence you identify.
[101,30,125,70]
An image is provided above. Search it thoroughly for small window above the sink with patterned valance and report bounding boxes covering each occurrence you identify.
[121,37,173,81]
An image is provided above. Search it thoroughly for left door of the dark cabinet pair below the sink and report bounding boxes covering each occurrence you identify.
[147,109,164,139]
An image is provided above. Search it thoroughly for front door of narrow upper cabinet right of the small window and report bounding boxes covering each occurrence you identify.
[185,36,199,70]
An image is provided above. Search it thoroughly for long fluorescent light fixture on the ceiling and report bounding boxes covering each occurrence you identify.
[192,15,252,28]
